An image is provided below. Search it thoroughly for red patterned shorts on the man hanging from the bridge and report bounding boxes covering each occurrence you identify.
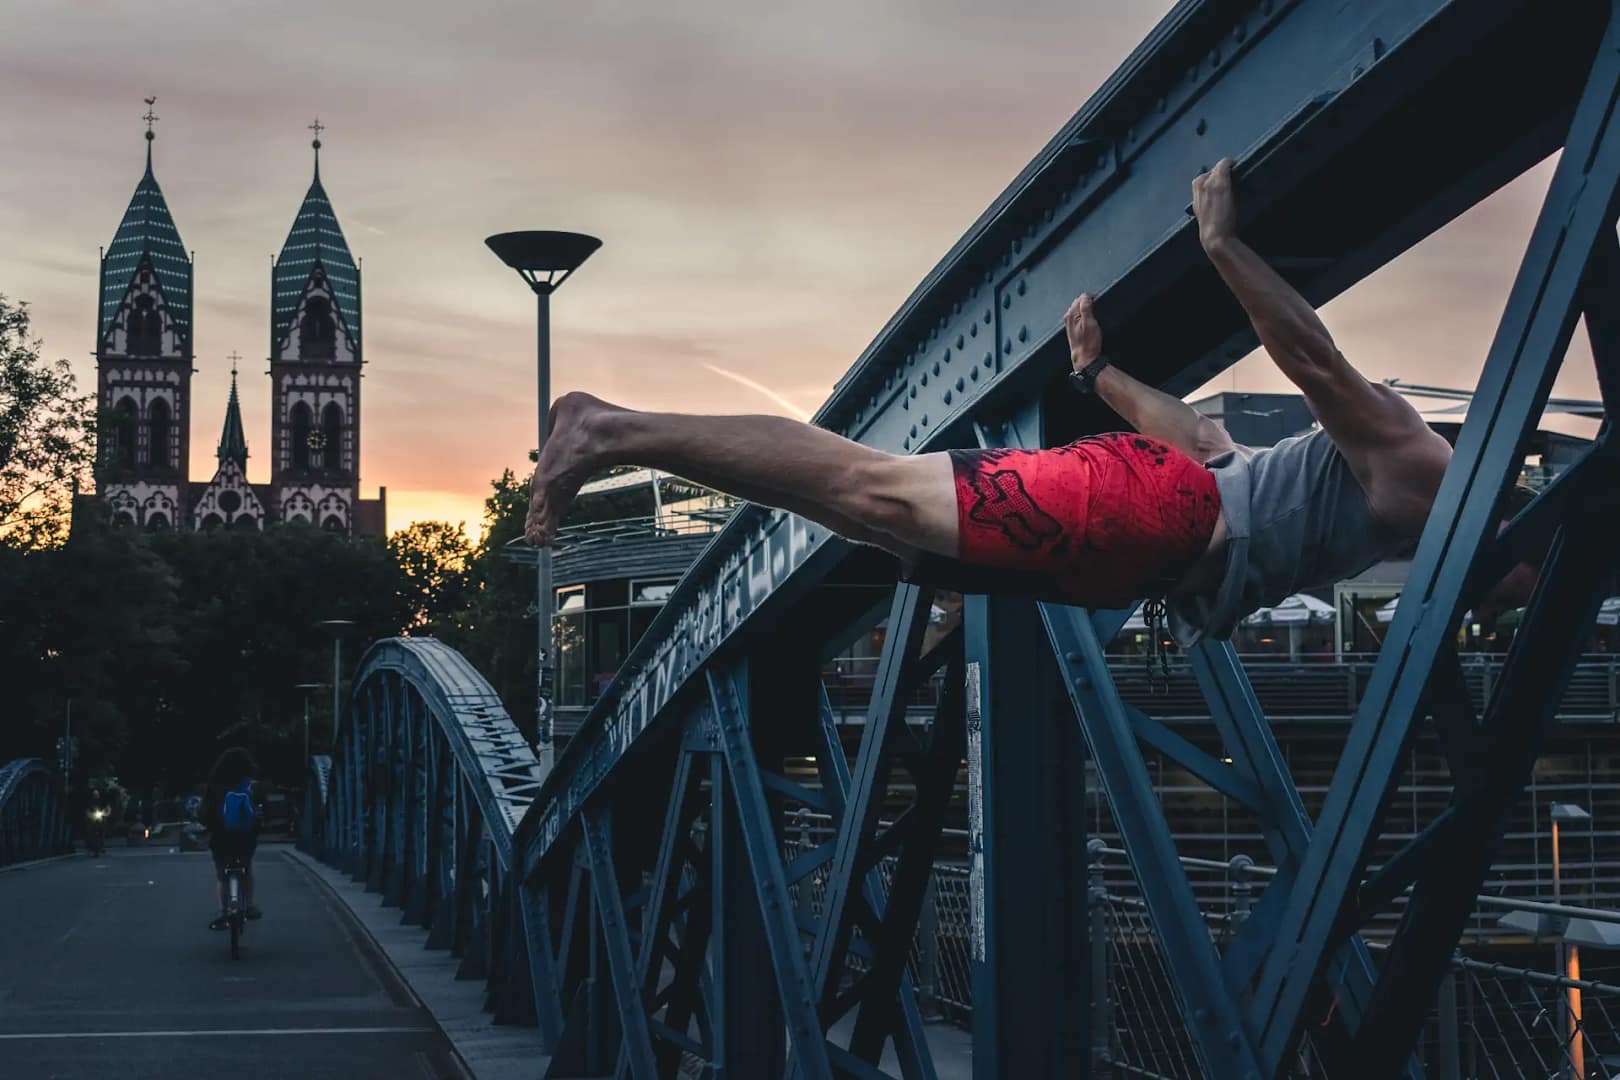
[941,432,1220,607]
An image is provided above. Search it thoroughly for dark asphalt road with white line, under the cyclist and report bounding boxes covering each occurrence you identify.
[0,845,463,1080]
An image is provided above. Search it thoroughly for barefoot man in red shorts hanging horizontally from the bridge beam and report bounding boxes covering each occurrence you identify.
[527,160,1533,634]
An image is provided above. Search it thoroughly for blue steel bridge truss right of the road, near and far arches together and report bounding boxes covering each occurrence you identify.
[306,0,1620,1080]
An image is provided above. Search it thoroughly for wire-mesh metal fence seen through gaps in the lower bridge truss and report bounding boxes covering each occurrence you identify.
[784,811,1620,1080]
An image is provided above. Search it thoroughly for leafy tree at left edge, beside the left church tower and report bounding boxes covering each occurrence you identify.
[0,295,96,547]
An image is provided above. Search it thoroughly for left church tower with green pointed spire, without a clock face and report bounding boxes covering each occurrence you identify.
[96,97,193,529]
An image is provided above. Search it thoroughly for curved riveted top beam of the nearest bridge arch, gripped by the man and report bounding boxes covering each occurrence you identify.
[520,0,1605,887]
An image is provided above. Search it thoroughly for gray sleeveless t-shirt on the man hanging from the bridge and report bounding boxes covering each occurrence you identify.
[1170,429,1405,648]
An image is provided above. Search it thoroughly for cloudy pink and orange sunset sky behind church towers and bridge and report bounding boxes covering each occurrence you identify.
[0,0,1594,529]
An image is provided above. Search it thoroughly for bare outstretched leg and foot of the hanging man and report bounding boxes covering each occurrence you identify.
[528,393,957,559]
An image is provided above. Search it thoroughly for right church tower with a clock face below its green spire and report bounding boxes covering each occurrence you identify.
[271,120,381,534]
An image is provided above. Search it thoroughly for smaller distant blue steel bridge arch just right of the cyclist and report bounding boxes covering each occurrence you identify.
[301,638,539,1022]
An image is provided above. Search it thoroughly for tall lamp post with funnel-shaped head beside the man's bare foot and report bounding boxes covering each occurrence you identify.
[484,232,603,776]
